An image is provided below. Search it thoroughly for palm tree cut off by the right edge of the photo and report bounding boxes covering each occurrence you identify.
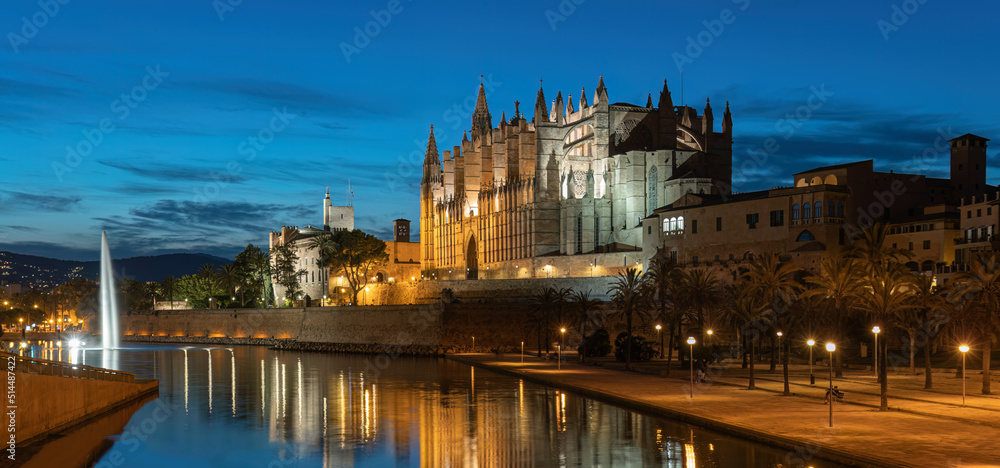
[954,252,1000,395]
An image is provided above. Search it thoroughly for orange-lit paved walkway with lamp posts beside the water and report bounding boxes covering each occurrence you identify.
[452,354,1000,467]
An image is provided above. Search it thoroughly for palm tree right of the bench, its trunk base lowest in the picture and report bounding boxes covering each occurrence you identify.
[855,264,917,411]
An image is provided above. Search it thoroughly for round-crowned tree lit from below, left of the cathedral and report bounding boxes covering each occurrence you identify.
[330,229,389,304]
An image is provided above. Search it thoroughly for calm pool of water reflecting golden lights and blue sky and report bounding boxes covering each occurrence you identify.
[39,345,852,468]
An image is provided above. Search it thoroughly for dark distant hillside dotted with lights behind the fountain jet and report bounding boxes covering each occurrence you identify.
[0,252,232,288]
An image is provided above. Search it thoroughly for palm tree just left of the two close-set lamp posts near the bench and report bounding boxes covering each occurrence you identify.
[743,252,800,396]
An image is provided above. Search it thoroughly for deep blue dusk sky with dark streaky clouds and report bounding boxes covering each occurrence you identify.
[0,0,1000,260]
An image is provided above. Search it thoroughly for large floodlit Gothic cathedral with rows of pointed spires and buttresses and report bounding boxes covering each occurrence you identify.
[420,77,733,279]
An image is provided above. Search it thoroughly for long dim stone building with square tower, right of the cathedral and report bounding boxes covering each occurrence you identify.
[643,134,996,274]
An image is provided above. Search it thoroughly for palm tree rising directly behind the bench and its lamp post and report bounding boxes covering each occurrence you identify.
[802,256,861,378]
